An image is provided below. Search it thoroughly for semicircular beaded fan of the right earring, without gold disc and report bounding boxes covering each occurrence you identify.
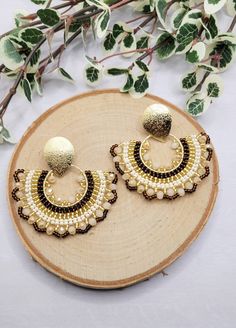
[110,133,213,200]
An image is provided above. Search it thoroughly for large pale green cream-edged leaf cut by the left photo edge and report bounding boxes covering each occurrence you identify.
[0,37,24,71]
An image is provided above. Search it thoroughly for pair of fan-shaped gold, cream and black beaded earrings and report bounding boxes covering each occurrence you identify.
[12,104,213,237]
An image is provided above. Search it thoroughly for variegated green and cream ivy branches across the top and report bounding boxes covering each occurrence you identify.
[0,0,236,143]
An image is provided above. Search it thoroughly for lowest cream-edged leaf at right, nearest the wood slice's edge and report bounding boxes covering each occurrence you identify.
[186,94,210,117]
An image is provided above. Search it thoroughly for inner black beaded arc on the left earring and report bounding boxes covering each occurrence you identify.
[37,171,94,213]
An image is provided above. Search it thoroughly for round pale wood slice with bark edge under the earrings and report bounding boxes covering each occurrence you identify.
[8,90,218,289]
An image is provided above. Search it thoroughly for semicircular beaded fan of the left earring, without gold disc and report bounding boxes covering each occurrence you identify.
[12,169,117,237]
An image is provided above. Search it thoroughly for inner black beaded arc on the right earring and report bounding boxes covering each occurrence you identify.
[134,138,189,179]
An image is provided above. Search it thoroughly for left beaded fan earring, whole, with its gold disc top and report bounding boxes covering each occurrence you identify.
[12,137,117,237]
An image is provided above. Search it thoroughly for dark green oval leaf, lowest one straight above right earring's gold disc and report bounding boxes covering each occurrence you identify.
[156,32,176,60]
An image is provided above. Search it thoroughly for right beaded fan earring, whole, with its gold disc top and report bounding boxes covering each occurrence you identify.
[110,104,213,200]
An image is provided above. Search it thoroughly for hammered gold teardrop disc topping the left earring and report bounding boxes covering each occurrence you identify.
[44,137,74,176]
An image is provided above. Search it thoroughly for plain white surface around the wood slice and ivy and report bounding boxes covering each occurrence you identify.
[0,0,236,328]
